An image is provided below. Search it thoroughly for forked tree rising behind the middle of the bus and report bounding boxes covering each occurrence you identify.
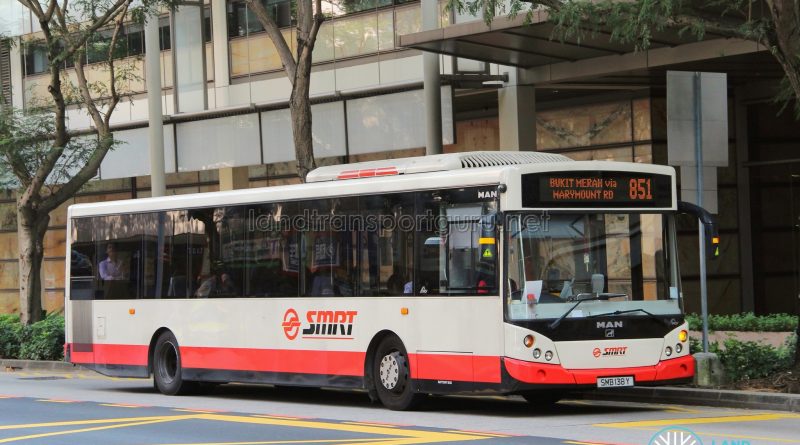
[245,0,325,182]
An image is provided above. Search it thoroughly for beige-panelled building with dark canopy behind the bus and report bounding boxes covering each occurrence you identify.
[0,0,800,313]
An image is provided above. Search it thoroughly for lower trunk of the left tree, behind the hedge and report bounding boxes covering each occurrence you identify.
[17,207,50,324]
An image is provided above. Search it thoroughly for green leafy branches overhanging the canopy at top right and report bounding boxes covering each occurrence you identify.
[449,0,800,112]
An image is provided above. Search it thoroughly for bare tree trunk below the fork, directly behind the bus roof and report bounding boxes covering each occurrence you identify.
[289,67,317,182]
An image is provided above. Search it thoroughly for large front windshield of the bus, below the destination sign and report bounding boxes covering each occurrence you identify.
[505,212,681,320]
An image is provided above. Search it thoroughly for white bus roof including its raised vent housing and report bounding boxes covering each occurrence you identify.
[68,152,675,218]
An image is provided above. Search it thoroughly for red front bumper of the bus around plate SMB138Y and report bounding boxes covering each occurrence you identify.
[503,355,694,387]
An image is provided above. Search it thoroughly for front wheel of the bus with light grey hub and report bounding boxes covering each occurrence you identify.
[372,336,424,410]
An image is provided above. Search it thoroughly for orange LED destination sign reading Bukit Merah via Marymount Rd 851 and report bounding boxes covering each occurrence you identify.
[522,171,672,208]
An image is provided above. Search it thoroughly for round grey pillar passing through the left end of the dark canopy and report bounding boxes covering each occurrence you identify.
[422,0,442,155]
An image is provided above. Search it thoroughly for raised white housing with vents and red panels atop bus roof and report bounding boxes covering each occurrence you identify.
[306,151,571,182]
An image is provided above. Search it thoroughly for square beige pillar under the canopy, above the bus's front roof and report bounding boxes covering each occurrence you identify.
[497,70,536,151]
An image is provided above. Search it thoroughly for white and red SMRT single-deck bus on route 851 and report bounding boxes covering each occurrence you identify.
[65,152,694,410]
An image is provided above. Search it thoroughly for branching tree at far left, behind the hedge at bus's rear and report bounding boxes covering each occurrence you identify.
[0,0,167,324]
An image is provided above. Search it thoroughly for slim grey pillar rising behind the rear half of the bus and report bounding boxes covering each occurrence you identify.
[144,15,167,196]
